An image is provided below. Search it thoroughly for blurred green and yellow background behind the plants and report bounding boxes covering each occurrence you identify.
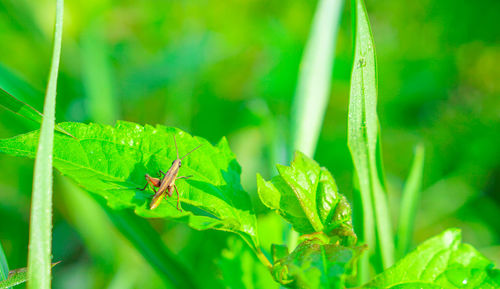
[0,0,500,288]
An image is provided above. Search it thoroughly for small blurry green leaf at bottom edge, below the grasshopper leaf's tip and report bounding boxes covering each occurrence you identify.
[217,238,279,289]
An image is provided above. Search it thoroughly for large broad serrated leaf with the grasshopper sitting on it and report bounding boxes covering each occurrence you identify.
[0,121,258,245]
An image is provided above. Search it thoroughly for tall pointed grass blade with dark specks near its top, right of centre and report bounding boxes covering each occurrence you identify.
[348,0,394,281]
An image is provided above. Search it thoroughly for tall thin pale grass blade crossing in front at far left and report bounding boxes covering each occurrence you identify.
[28,0,64,289]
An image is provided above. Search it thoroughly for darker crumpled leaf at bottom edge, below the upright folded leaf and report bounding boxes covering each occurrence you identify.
[272,233,363,289]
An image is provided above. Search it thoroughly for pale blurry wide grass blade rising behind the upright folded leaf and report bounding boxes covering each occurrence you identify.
[289,0,344,157]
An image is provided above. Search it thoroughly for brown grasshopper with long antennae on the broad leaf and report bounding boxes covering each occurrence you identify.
[137,135,203,212]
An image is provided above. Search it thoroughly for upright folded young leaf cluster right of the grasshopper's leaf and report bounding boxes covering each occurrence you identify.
[257,152,355,243]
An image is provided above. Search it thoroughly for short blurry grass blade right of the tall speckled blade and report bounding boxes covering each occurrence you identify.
[396,144,425,258]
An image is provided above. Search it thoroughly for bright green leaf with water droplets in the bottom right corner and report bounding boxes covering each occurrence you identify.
[362,229,500,289]
